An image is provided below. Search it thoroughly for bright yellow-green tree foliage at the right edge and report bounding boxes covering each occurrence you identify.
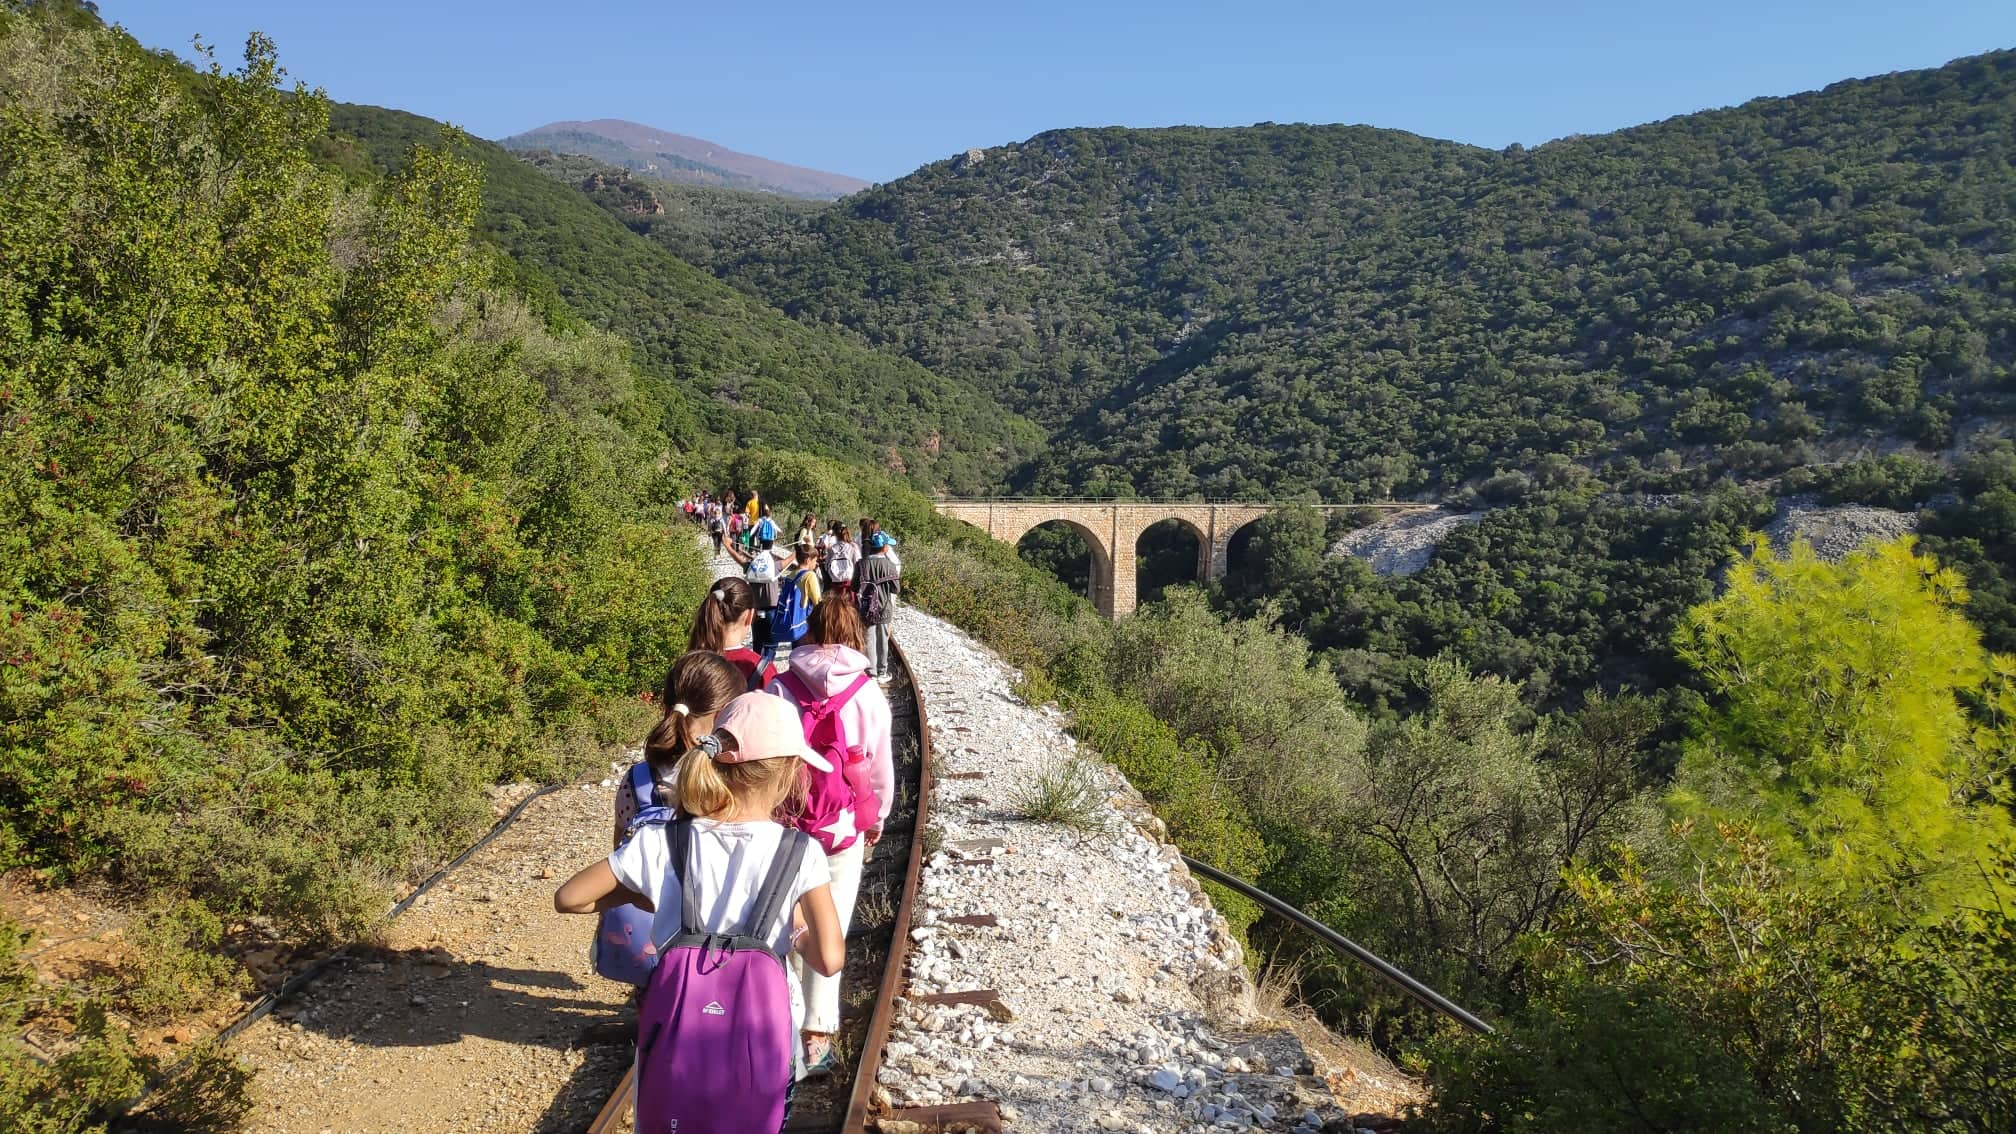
[1673,541,2012,908]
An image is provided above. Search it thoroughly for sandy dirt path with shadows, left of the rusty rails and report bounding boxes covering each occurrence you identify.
[234,770,631,1134]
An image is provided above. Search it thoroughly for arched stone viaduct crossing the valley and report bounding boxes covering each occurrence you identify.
[937,498,1433,617]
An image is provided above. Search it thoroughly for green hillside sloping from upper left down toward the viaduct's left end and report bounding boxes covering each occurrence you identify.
[329,103,1040,492]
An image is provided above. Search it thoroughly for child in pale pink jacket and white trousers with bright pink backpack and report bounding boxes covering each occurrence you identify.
[770,595,895,1075]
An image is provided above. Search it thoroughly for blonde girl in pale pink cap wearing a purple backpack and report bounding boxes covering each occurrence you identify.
[552,692,847,1134]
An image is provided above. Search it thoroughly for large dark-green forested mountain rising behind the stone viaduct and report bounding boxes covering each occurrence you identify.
[649,52,2016,500]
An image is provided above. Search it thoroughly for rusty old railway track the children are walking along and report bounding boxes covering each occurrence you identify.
[589,644,931,1134]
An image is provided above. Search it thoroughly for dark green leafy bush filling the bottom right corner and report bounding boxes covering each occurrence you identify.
[1409,825,2016,1134]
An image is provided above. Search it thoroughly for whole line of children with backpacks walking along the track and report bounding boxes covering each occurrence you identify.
[554,494,901,1134]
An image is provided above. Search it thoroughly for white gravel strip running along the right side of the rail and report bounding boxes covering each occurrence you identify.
[875,607,1419,1134]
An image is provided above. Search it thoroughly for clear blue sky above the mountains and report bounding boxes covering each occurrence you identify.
[99,0,2016,182]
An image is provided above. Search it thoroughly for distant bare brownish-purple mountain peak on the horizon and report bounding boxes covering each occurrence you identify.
[500,119,869,200]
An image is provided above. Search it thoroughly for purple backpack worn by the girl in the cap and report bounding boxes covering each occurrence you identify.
[637,817,808,1134]
